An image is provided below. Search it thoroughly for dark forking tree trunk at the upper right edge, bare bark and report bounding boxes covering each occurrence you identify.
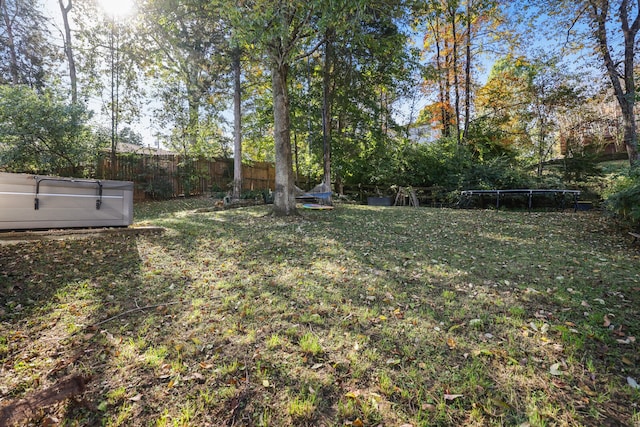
[590,0,640,166]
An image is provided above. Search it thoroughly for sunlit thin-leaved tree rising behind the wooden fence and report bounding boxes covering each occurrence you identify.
[137,0,231,160]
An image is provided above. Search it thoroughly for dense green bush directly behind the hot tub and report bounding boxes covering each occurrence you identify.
[0,86,96,176]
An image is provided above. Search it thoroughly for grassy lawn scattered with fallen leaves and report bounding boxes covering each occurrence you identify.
[0,200,640,426]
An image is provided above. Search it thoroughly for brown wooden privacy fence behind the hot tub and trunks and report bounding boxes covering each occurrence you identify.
[96,154,275,200]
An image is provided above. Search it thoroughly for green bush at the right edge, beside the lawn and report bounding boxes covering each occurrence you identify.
[606,166,640,226]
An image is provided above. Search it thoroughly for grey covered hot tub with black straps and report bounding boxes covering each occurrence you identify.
[0,172,133,230]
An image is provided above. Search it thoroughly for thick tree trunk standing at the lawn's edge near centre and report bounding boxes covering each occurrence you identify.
[271,62,297,216]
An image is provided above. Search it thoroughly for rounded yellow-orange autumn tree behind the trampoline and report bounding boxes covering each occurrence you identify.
[478,56,582,172]
